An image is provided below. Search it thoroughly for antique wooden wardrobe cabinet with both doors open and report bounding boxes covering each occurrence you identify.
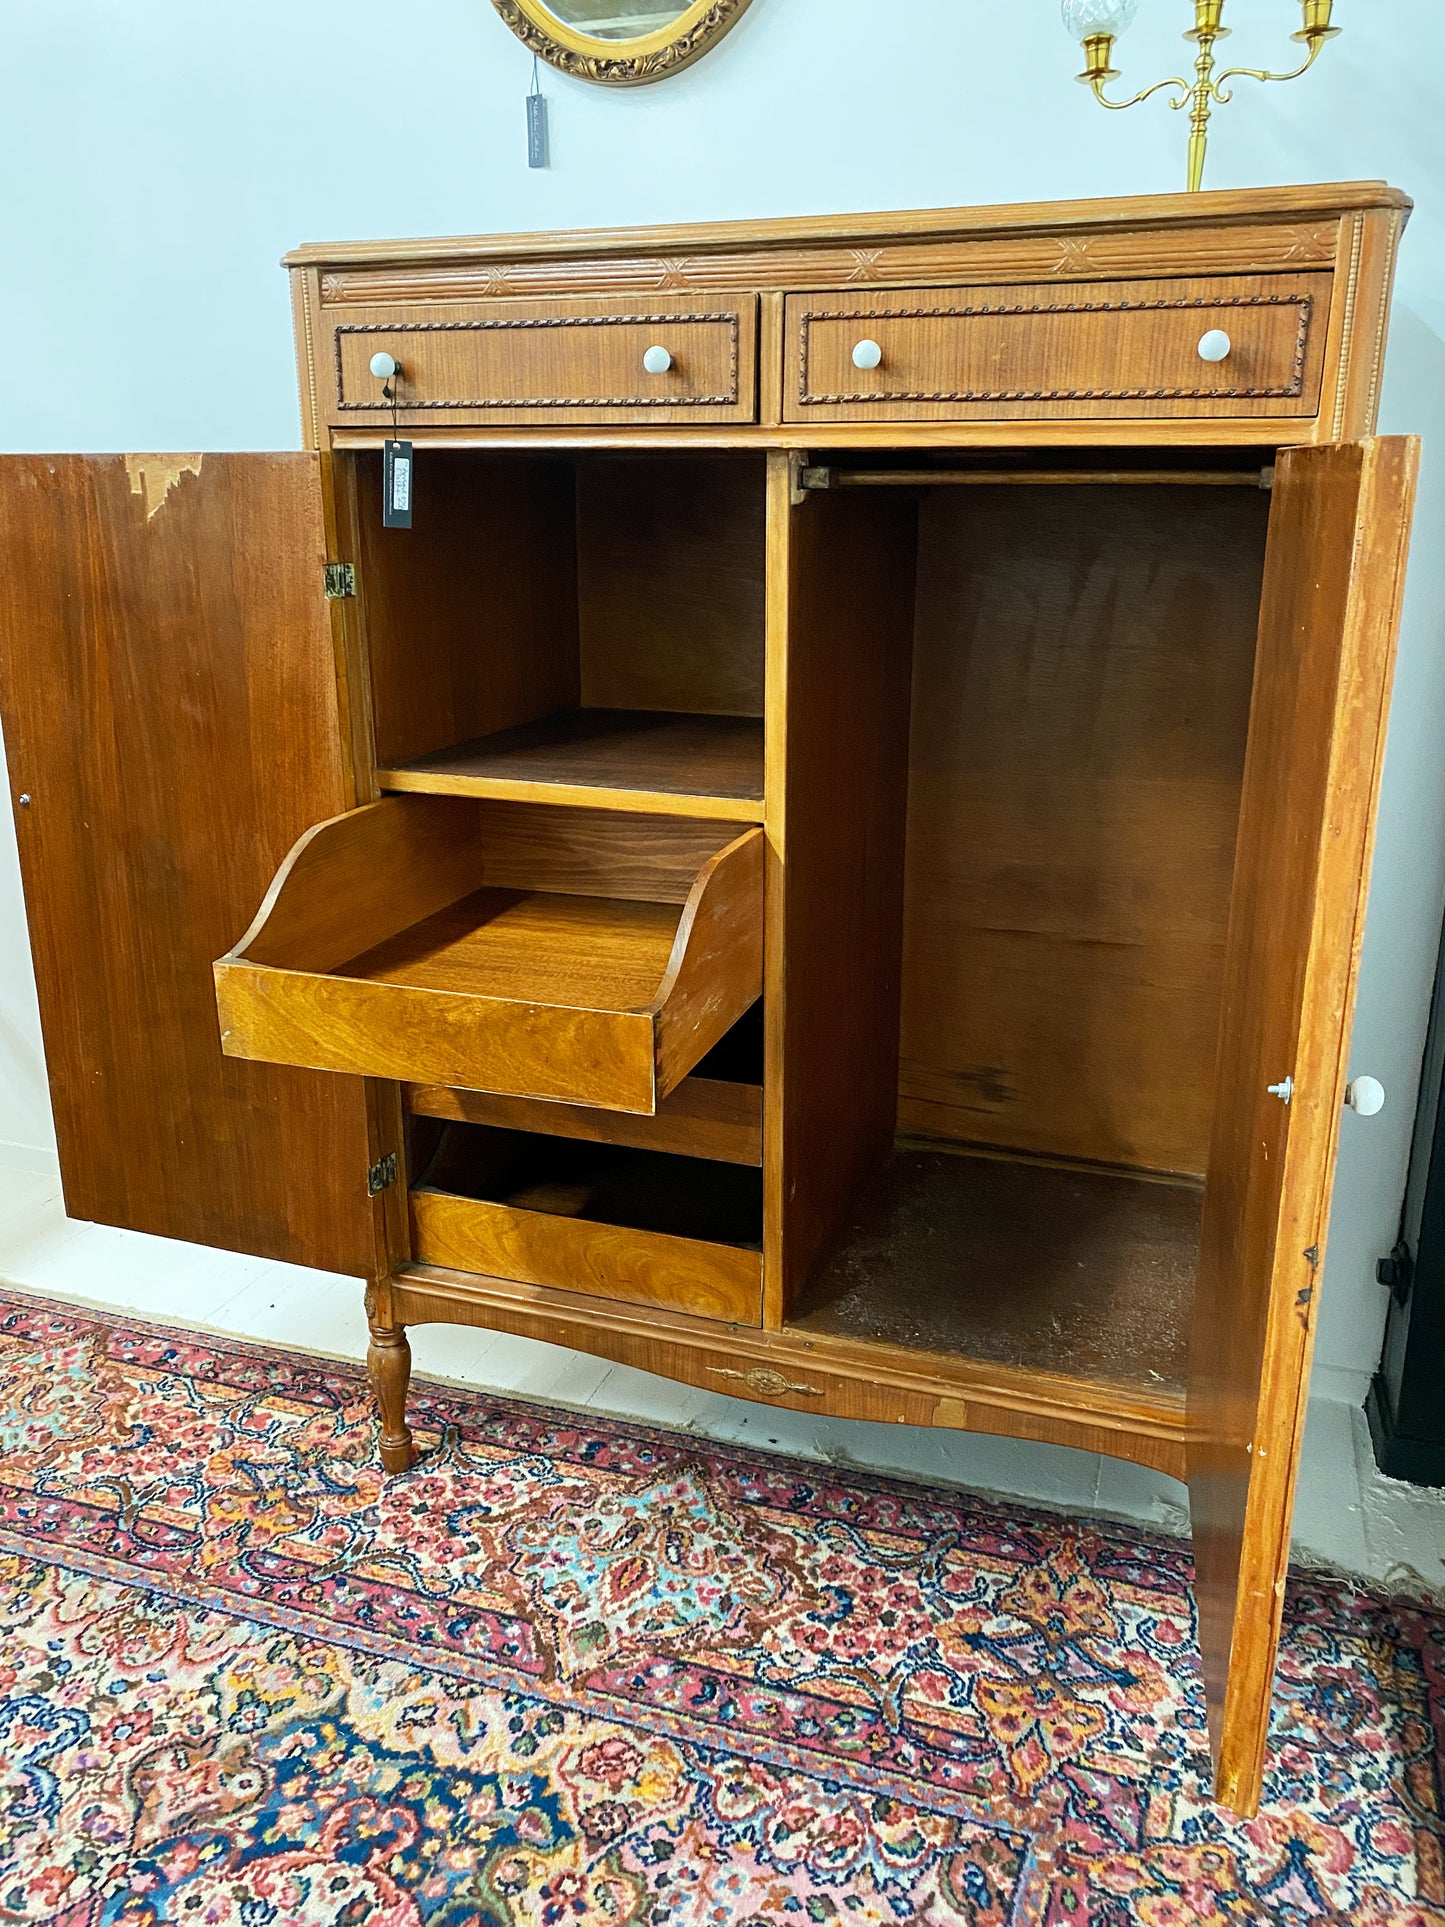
[0,183,1416,1809]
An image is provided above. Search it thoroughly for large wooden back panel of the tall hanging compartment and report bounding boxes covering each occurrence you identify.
[898,488,1268,1174]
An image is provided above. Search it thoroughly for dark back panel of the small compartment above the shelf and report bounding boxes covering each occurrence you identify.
[578,455,765,717]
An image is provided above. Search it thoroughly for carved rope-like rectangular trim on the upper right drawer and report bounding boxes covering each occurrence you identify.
[798,295,1314,409]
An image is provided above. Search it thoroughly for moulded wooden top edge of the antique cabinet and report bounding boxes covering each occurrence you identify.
[281,181,1414,268]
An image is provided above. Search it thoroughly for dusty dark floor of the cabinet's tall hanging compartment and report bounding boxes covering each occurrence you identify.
[788,1150,1202,1393]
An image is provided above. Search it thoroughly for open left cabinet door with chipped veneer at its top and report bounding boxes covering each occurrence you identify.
[0,455,376,1276]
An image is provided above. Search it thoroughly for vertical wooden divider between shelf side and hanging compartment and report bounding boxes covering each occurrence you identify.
[765,459,917,1324]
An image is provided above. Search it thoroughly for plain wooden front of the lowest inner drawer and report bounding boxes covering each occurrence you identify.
[410,1189,763,1326]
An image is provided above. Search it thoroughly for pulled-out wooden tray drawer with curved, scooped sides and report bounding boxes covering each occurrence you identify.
[216,796,763,1114]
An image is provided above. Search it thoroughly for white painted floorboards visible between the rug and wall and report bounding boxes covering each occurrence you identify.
[0,1168,1445,1594]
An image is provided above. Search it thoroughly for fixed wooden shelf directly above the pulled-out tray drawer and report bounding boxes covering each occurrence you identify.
[376,709,763,823]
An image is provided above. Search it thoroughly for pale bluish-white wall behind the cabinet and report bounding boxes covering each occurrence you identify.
[0,0,1445,1389]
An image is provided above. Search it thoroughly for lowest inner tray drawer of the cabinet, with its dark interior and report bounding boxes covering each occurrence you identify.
[410,1125,763,1326]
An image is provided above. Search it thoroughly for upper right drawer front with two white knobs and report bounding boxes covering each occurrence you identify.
[786,274,1333,422]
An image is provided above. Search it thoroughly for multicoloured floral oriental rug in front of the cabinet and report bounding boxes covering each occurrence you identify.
[0,1295,1445,1927]
